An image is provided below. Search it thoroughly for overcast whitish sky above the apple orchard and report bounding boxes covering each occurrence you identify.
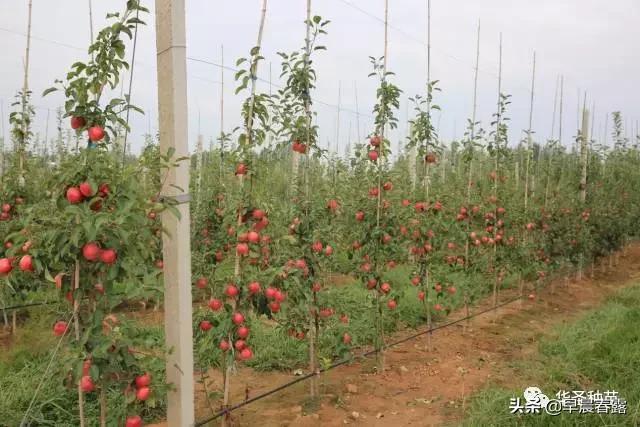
[0,0,640,155]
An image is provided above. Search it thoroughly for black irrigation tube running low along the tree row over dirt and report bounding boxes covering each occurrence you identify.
[194,295,522,427]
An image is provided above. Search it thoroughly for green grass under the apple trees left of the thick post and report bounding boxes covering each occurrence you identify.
[0,305,166,427]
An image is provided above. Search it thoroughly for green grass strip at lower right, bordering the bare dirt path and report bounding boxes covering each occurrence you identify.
[463,284,640,427]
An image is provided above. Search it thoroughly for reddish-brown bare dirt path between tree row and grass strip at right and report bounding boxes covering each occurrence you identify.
[154,244,640,427]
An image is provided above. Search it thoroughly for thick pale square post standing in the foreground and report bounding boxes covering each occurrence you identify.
[156,0,195,426]
